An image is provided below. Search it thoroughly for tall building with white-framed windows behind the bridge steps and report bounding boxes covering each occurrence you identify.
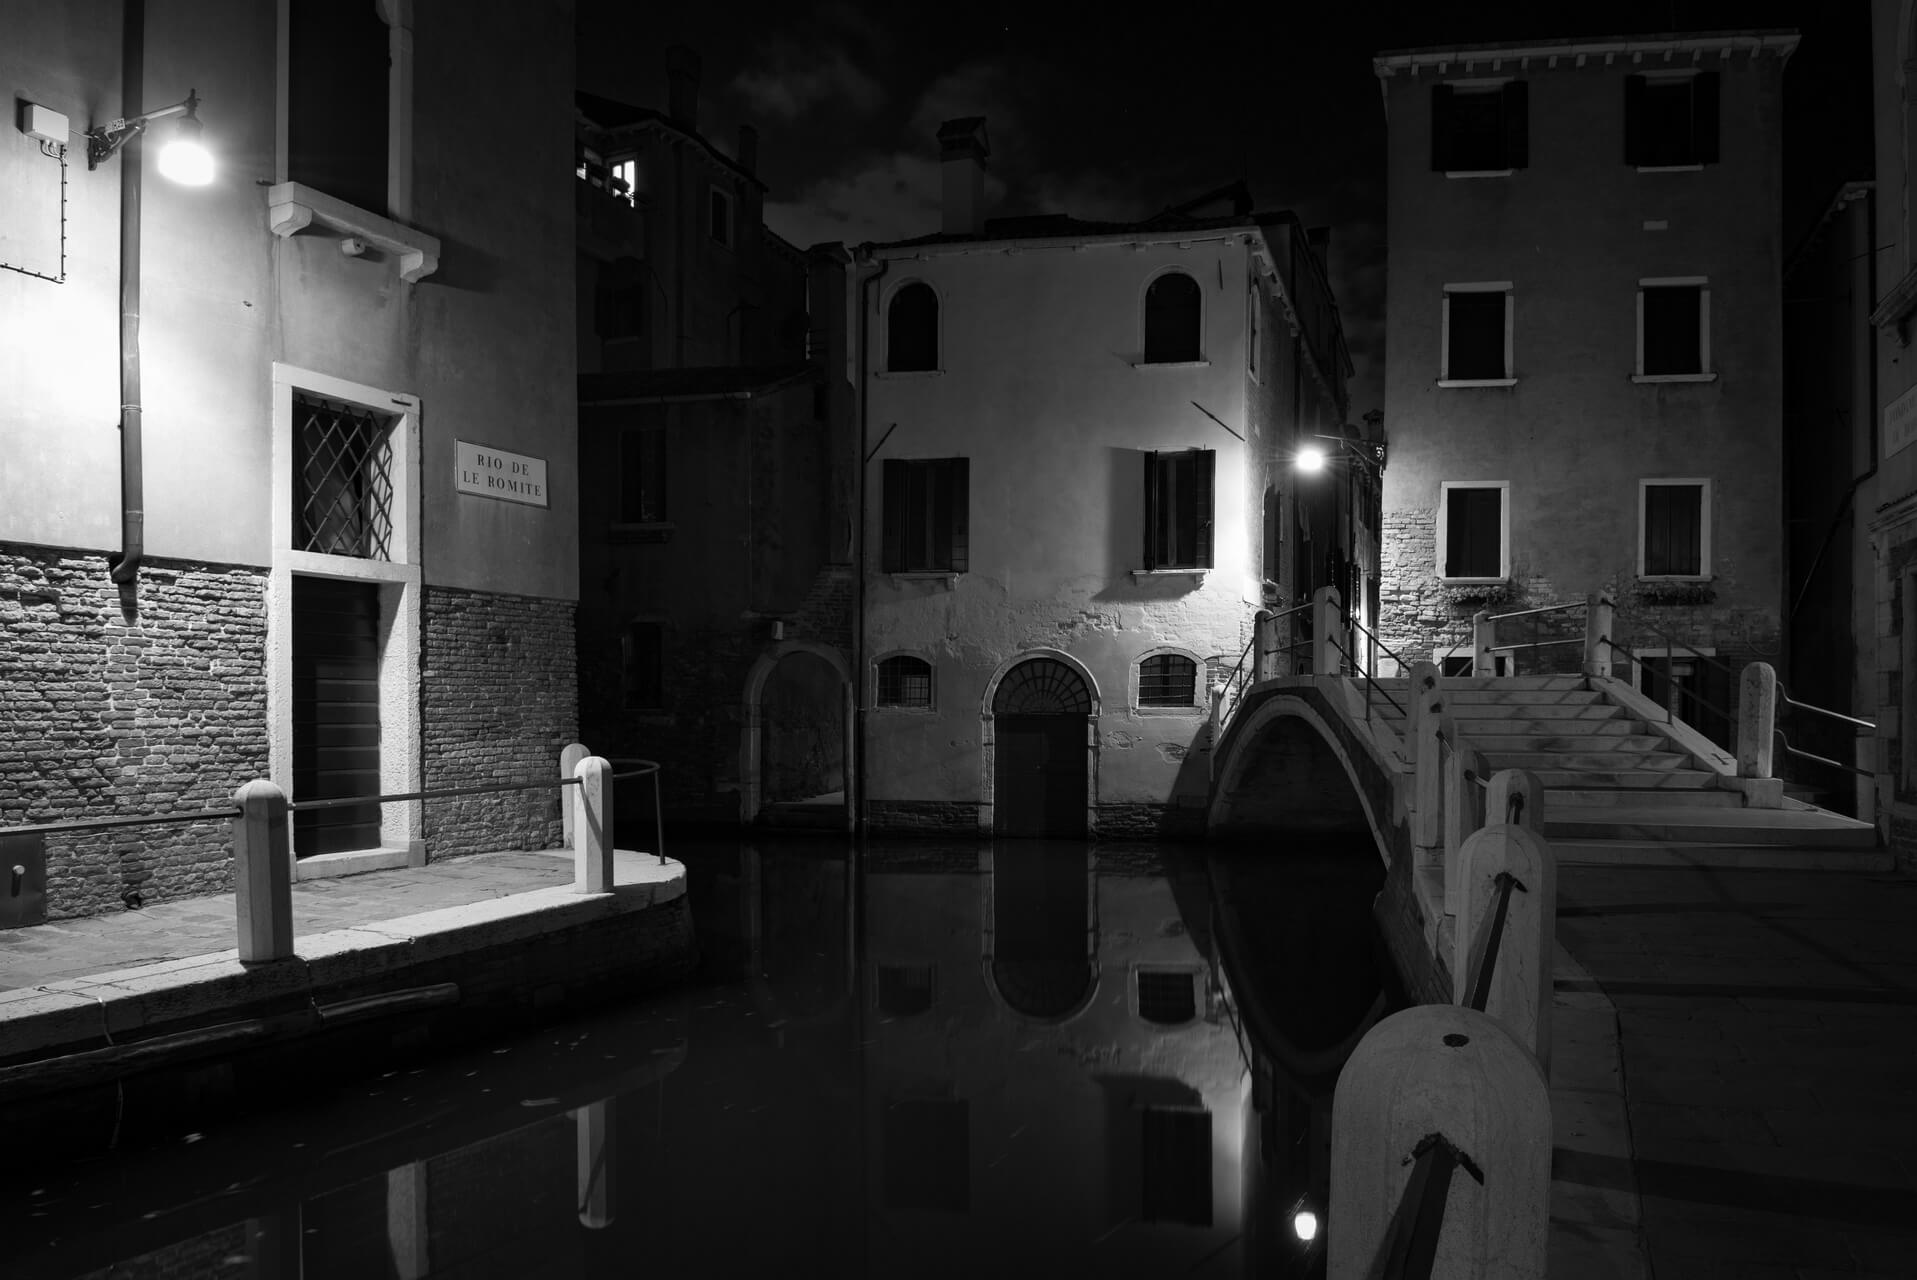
[1373,33,1796,720]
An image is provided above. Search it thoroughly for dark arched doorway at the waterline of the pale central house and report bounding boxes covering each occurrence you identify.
[991,657,1093,839]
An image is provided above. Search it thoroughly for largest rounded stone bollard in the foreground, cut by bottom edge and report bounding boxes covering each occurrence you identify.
[1327,1004,1551,1280]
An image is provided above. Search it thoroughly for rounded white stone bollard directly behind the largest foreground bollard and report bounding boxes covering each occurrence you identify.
[1451,822,1557,1079]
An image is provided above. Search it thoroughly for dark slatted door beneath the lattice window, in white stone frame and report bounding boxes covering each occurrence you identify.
[293,577,380,857]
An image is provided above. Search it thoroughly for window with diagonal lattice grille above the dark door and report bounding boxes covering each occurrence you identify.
[293,391,397,560]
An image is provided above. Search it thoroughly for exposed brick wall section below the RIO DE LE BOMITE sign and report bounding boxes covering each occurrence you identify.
[420,586,571,858]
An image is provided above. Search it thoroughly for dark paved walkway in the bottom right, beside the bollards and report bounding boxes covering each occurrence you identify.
[1551,866,1917,1280]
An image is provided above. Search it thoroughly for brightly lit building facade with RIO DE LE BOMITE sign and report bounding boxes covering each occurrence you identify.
[0,0,577,916]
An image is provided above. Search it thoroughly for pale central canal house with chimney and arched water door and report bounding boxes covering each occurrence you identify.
[851,119,1355,837]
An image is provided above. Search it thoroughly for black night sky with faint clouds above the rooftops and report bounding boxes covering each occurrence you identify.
[579,0,1871,418]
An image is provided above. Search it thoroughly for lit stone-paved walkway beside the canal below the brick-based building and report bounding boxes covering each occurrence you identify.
[0,849,573,991]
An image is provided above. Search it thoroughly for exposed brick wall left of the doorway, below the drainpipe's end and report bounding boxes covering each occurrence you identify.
[0,544,266,918]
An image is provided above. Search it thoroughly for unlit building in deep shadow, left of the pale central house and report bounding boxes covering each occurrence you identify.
[575,46,853,823]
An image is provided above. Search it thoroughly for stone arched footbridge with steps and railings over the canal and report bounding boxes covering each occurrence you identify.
[1208,594,1888,1002]
